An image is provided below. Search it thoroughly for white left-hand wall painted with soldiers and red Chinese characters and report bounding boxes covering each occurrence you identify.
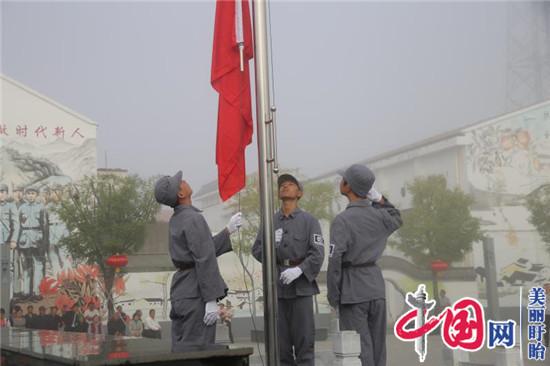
[0,77,98,306]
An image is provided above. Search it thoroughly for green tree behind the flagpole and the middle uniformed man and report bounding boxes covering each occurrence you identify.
[230,175,338,315]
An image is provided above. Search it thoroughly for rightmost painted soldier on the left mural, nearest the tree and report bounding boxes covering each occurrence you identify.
[46,185,69,274]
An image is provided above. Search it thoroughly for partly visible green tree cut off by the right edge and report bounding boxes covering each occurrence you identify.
[526,184,550,253]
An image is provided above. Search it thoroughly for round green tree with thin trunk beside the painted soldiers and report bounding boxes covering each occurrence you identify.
[57,175,160,315]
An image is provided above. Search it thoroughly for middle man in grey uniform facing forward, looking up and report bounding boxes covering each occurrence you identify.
[252,174,325,366]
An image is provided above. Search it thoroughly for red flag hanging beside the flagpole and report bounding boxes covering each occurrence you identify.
[210,0,252,201]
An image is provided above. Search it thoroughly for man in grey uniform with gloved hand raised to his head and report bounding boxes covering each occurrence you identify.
[327,164,402,366]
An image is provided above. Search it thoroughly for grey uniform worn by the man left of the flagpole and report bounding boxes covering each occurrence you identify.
[169,205,232,350]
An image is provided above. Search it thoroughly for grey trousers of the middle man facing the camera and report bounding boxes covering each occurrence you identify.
[277,296,315,366]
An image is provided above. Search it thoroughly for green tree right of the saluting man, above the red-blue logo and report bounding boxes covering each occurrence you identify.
[391,175,482,296]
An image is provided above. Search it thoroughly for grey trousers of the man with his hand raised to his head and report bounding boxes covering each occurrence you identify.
[339,299,386,366]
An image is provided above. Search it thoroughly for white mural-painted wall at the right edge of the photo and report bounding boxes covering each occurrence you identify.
[466,103,550,306]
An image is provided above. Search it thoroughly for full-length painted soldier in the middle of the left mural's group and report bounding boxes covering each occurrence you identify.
[17,187,49,297]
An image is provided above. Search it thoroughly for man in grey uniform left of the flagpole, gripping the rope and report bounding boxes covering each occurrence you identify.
[155,171,242,351]
